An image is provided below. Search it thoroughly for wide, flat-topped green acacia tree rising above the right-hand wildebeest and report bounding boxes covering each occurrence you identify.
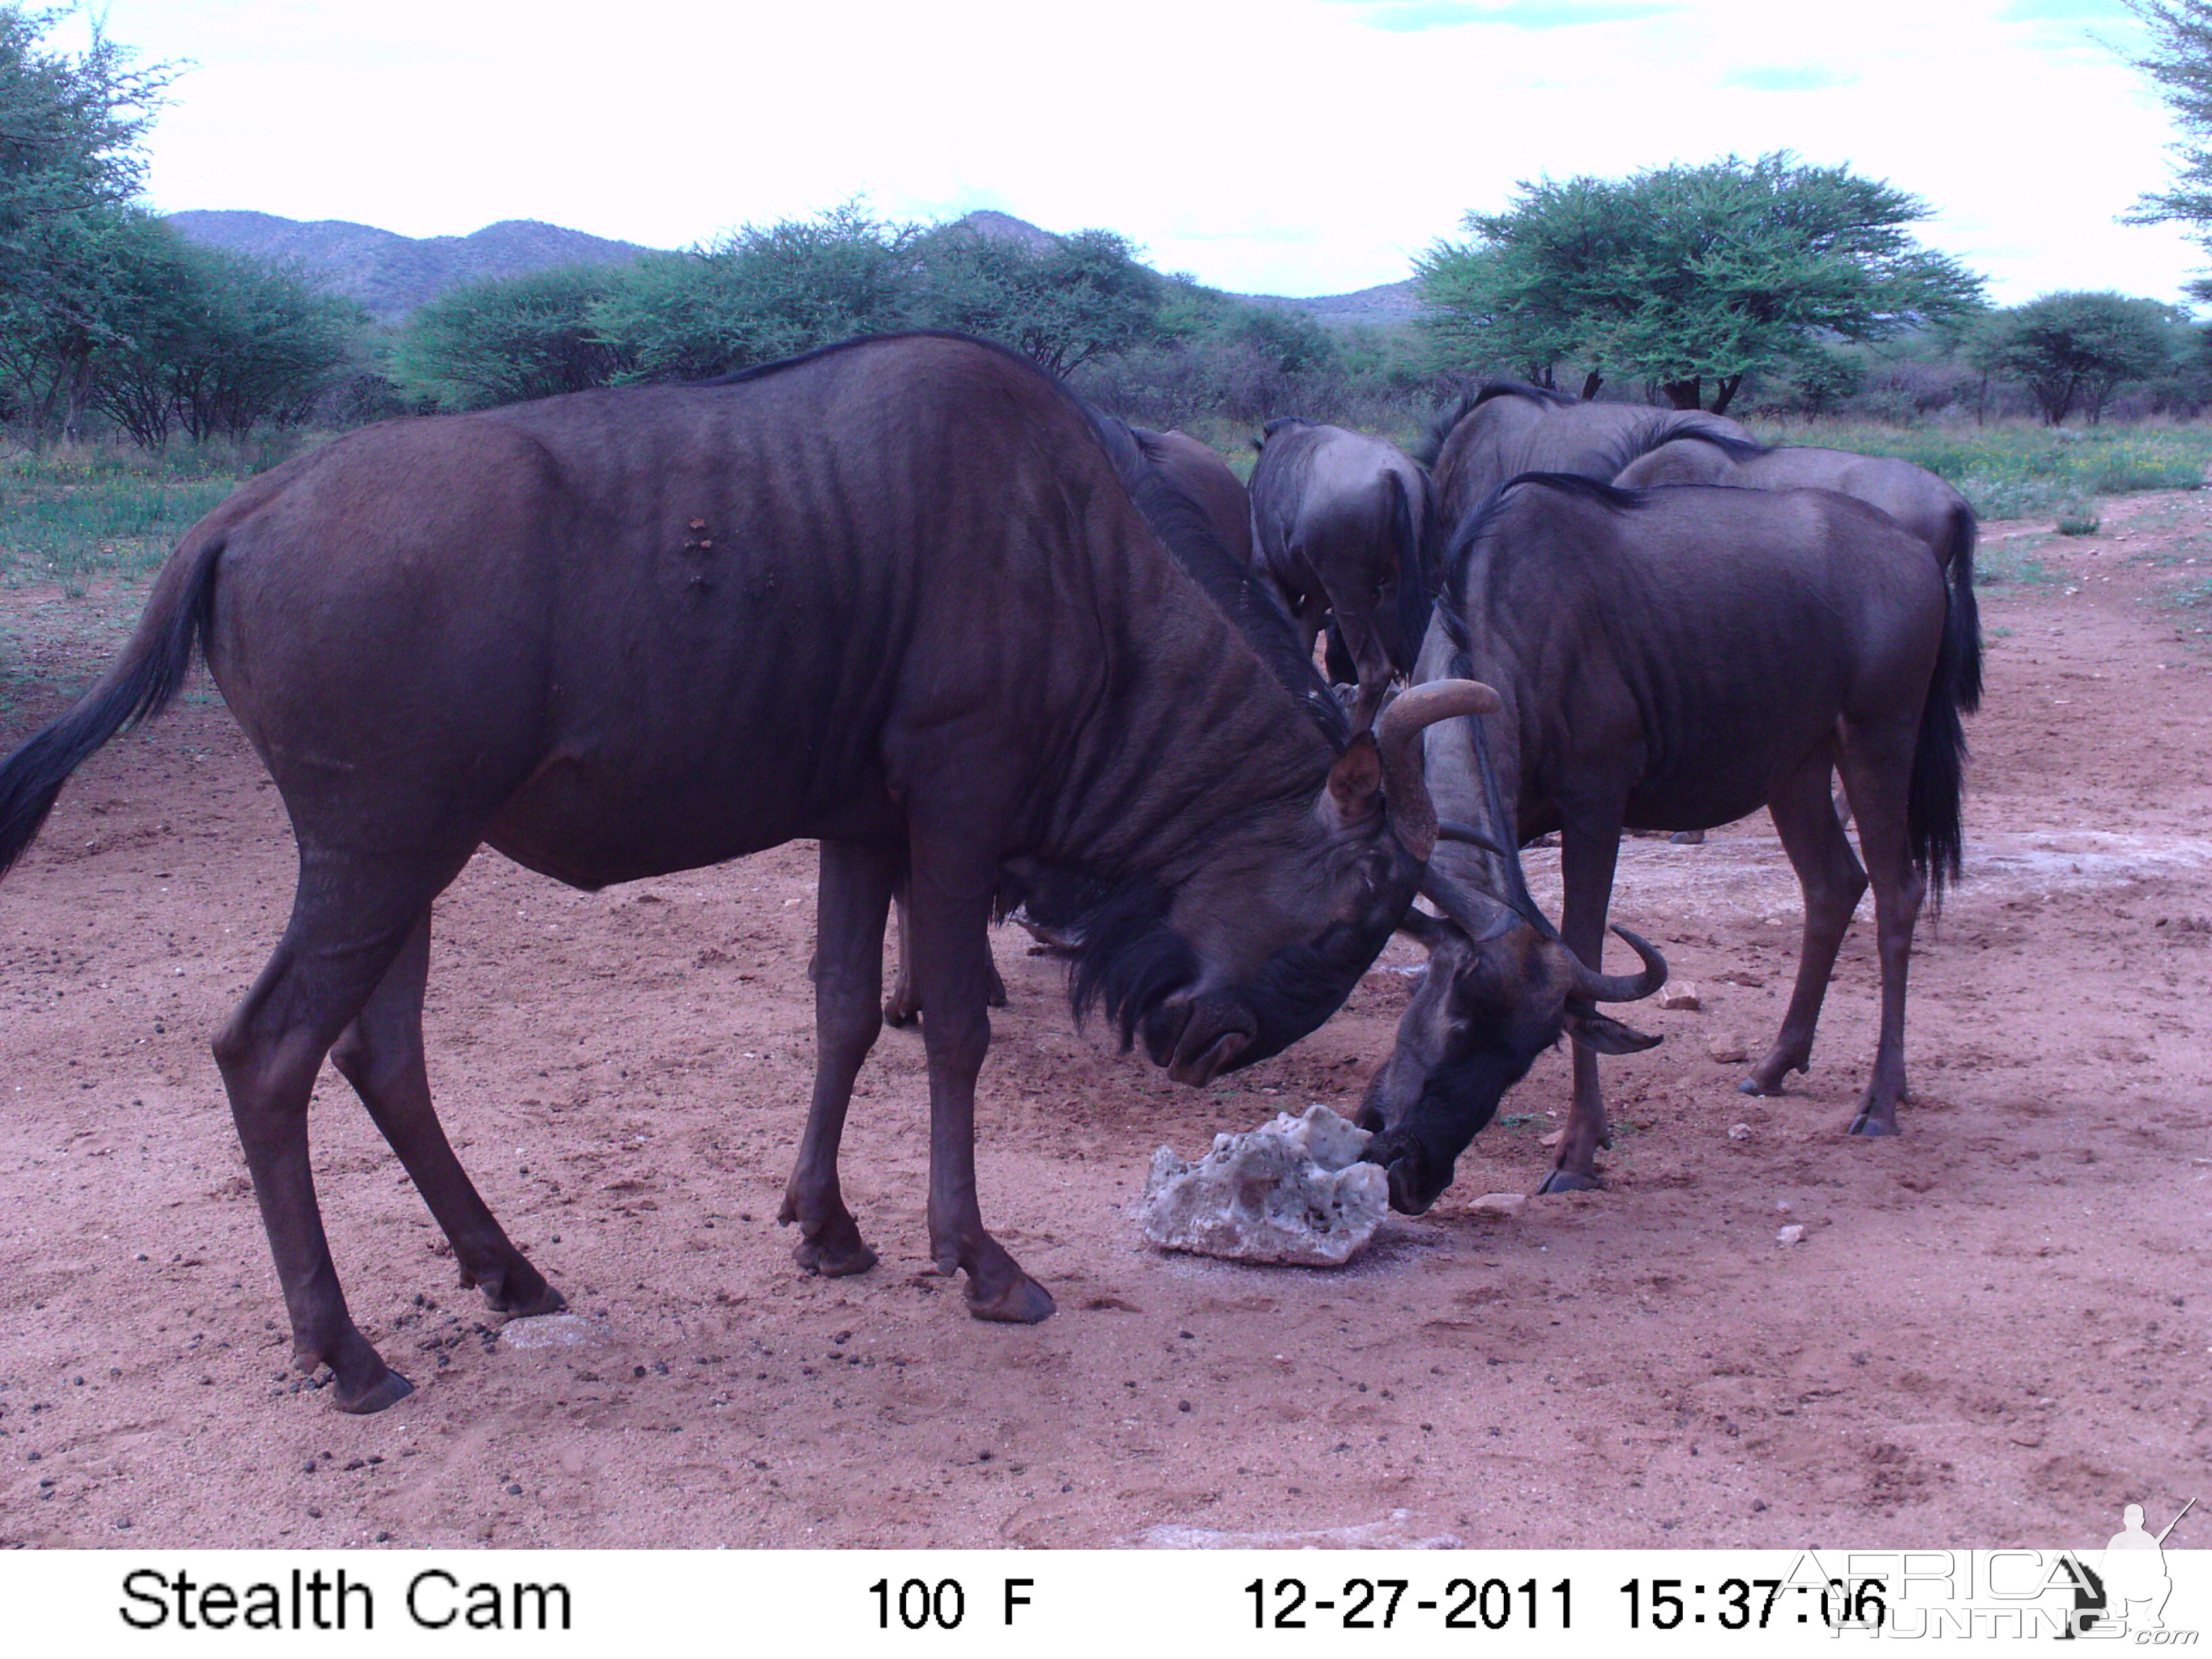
[1416,150,1982,413]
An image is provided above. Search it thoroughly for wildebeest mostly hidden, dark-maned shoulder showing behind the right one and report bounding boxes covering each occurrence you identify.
[1420,380,1757,533]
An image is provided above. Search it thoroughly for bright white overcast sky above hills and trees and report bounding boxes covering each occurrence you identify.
[53,0,2212,303]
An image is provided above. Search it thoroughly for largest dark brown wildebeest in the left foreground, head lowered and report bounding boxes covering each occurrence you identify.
[0,336,1486,1411]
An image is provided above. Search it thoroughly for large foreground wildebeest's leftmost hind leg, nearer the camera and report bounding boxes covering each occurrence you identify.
[215,836,469,1411]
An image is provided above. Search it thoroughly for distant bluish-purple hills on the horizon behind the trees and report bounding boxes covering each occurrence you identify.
[168,208,1420,327]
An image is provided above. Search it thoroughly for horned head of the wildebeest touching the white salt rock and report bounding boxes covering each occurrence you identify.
[1358,858,1666,1214]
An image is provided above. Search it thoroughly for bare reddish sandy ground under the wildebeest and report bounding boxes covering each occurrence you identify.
[0,495,2212,1549]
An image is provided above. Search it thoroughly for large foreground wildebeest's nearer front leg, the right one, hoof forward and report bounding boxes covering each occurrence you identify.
[907,834,1053,1325]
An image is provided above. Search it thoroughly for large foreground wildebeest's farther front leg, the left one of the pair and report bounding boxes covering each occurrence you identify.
[779,840,905,1279]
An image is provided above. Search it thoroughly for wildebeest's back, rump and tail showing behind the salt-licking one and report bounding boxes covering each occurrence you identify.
[1612,434,1982,714]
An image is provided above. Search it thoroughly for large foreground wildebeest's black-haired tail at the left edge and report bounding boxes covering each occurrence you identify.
[0,533,224,876]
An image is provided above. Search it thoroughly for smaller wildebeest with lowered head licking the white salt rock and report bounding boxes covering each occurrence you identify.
[1365,476,1964,1208]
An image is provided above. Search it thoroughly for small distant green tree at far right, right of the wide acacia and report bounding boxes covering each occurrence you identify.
[1967,292,2188,427]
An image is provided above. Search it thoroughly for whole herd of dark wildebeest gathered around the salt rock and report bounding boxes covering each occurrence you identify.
[0,334,1980,1411]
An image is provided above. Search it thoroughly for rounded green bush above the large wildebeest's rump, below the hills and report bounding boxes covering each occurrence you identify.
[392,266,633,409]
